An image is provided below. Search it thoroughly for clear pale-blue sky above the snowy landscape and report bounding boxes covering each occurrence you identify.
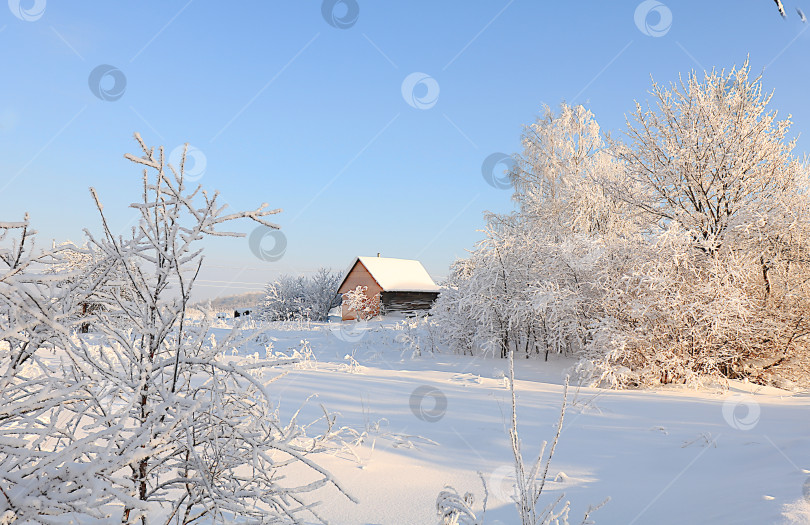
[0,0,810,297]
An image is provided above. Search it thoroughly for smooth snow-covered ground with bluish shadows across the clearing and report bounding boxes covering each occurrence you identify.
[214,320,810,525]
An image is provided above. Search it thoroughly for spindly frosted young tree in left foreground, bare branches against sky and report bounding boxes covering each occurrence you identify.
[60,134,354,524]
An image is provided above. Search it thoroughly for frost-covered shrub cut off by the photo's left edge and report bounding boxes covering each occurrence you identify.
[0,216,126,523]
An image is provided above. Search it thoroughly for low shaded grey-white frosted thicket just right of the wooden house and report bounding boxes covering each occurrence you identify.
[432,228,604,359]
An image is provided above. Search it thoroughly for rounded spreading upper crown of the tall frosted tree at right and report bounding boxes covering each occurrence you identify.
[613,61,803,253]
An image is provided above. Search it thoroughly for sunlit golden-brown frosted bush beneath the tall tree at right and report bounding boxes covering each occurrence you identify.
[581,211,808,386]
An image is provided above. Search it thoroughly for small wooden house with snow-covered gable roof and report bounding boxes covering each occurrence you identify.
[338,254,439,321]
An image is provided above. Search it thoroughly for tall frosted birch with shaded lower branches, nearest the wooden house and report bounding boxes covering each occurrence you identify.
[433,104,634,359]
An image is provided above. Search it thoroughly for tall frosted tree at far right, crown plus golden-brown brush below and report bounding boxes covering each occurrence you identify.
[589,62,810,385]
